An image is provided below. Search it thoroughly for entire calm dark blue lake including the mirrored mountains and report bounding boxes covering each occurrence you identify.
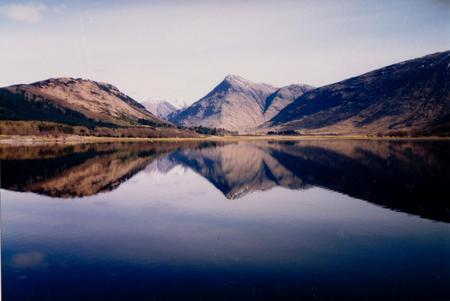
[0,141,450,300]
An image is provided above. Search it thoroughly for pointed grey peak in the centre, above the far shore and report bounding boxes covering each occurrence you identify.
[170,75,310,133]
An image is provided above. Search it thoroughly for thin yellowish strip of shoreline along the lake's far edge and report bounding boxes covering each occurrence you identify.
[0,135,450,145]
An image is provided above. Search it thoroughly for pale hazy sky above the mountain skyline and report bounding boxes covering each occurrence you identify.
[0,0,450,103]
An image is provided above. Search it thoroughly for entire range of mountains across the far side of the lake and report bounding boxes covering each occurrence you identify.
[0,51,450,137]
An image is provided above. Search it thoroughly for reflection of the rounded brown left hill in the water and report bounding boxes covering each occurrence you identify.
[0,143,207,198]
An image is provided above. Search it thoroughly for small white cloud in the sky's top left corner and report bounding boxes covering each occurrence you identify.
[0,3,47,23]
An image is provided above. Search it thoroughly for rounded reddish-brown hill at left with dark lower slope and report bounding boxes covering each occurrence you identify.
[0,78,168,126]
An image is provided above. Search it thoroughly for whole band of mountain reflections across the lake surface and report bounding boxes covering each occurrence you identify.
[0,140,450,222]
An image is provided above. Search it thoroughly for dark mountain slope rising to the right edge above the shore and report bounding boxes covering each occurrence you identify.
[264,51,450,135]
